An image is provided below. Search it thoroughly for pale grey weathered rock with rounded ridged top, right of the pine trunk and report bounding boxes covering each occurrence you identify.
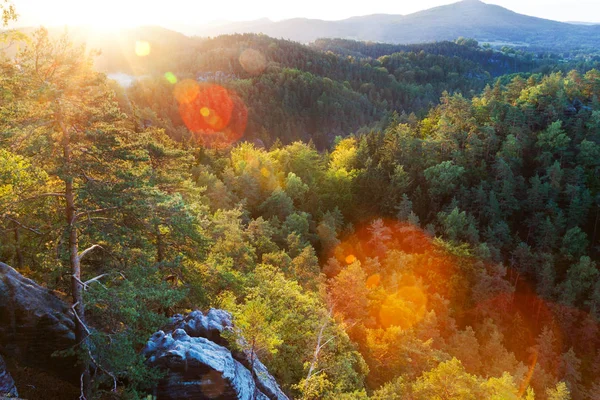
[144,309,288,400]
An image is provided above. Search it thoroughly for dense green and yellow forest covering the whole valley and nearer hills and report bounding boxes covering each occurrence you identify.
[0,5,600,400]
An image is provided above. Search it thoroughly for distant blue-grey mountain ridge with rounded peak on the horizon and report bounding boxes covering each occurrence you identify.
[186,0,600,50]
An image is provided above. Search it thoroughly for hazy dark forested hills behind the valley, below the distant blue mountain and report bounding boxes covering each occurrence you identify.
[88,29,599,149]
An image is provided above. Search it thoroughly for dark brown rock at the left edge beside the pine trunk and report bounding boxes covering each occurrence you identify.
[0,263,77,380]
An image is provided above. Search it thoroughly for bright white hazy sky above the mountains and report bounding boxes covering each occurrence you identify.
[12,0,600,27]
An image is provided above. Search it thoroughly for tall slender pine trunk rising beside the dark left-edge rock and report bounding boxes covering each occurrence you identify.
[59,111,91,399]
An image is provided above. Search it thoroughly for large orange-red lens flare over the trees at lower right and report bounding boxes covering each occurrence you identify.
[323,219,600,395]
